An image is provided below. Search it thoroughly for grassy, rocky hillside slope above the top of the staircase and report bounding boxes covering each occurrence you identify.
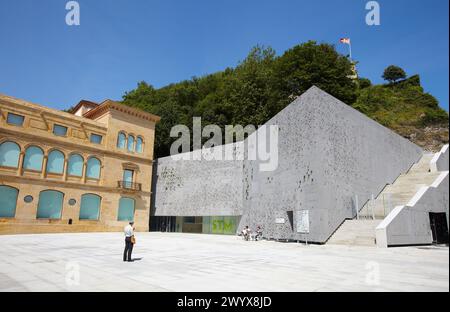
[352,75,449,152]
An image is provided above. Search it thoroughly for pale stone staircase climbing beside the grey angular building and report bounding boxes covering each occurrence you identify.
[327,154,440,246]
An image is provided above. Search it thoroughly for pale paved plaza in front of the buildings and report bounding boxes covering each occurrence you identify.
[0,233,449,292]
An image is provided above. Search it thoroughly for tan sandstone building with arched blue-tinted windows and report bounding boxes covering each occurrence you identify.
[0,94,159,234]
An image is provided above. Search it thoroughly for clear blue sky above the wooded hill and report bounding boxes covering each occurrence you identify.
[0,0,449,111]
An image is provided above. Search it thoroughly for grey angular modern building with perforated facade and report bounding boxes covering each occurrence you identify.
[152,87,448,243]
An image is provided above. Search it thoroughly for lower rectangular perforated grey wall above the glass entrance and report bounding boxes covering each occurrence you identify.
[154,143,243,216]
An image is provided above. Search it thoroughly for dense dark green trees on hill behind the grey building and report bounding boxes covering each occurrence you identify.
[123,41,428,157]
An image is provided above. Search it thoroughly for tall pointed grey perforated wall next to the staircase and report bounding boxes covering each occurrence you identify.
[241,87,423,242]
